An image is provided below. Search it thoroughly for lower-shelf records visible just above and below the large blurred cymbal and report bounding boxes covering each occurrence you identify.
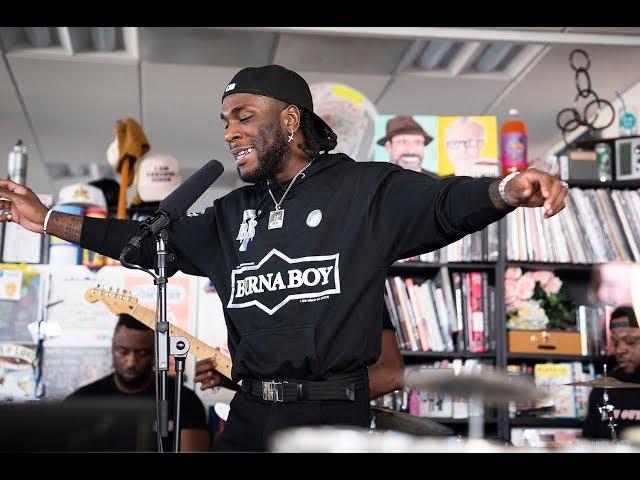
[371,358,497,424]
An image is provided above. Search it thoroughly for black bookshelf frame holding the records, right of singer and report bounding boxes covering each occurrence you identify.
[389,180,640,440]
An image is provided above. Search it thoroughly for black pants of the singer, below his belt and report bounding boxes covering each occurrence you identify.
[213,388,370,452]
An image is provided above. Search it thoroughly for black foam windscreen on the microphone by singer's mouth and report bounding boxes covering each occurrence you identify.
[160,160,224,220]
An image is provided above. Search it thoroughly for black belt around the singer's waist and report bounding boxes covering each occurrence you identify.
[242,372,368,402]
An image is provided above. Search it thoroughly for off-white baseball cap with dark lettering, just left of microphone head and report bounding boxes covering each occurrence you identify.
[135,153,182,202]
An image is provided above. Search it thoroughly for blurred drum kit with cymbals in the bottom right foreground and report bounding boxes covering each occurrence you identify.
[270,367,640,453]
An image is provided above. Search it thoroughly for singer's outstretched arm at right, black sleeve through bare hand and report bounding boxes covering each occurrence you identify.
[368,165,567,265]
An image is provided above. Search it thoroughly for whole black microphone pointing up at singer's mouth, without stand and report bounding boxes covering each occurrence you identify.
[120,160,224,263]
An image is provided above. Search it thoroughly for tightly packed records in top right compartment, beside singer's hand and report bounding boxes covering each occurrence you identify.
[506,187,640,269]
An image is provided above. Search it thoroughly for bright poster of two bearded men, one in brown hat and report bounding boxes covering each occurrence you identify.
[374,115,499,177]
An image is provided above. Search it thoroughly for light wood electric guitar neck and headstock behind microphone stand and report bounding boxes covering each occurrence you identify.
[84,287,231,380]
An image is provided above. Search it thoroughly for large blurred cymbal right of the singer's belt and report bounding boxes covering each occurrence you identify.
[405,368,547,404]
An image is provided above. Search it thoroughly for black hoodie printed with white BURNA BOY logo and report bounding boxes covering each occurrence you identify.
[80,154,510,380]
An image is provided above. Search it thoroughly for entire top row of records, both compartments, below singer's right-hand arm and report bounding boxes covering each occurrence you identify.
[392,182,640,270]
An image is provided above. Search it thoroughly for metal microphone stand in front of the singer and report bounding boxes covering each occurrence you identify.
[120,228,189,453]
